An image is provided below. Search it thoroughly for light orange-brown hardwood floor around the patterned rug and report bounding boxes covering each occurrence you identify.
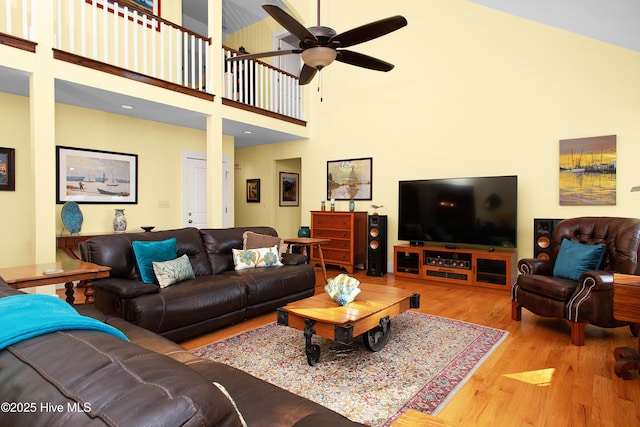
[66,267,640,427]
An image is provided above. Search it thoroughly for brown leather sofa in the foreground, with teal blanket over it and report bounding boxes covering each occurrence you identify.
[0,278,361,427]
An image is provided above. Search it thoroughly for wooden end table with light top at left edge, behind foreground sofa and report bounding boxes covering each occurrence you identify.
[0,260,111,304]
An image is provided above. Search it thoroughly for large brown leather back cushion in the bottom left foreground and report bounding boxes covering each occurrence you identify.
[0,331,242,426]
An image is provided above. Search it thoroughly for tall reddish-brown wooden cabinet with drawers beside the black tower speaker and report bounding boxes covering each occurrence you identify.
[311,211,367,273]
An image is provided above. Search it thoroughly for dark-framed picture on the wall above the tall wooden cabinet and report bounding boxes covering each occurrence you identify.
[327,157,373,200]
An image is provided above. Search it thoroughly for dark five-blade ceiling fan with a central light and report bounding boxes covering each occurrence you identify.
[227,0,407,85]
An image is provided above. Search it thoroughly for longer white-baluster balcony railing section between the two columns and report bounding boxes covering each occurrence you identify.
[56,0,212,93]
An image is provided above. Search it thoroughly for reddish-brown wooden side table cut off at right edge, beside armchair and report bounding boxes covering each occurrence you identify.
[613,273,640,380]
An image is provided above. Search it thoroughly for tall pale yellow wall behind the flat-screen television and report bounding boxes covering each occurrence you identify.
[236,0,640,260]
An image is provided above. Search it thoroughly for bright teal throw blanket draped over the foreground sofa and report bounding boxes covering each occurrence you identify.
[0,294,129,350]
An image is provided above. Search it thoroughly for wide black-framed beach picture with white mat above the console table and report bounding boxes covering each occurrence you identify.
[56,146,138,204]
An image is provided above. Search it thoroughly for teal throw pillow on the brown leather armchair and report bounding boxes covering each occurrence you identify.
[553,239,607,280]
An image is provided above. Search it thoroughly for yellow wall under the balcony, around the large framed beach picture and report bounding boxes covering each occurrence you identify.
[56,104,206,233]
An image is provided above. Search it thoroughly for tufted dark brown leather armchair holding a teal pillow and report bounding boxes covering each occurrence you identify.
[511,217,640,346]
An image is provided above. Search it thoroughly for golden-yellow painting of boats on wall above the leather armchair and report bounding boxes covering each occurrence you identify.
[560,135,617,206]
